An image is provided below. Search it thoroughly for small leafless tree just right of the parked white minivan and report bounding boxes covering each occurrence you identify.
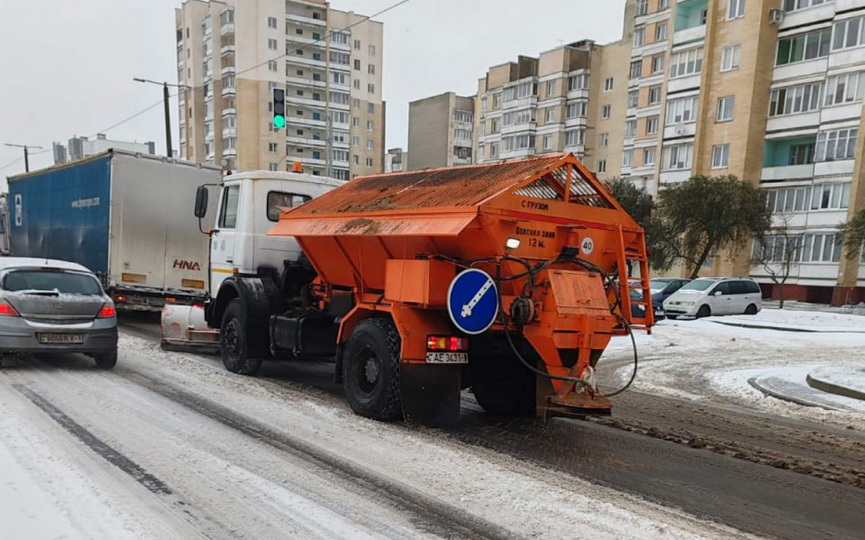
[751,214,805,309]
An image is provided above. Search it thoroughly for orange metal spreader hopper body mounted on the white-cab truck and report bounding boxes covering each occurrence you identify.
[269,154,654,412]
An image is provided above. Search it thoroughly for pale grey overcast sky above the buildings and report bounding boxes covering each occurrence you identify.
[0,0,625,181]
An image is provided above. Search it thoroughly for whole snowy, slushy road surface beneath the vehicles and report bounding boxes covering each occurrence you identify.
[0,310,865,538]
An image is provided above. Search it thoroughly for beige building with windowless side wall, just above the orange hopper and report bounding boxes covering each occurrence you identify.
[408,92,475,171]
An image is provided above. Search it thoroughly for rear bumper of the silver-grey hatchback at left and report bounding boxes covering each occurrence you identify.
[0,317,117,354]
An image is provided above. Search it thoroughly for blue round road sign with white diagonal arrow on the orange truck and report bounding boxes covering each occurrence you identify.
[448,268,499,334]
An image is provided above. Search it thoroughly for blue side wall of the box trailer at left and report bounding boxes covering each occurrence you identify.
[9,155,111,279]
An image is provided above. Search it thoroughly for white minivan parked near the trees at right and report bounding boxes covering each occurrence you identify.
[664,277,763,319]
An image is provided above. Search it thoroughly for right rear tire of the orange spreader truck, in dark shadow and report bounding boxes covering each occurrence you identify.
[469,334,537,417]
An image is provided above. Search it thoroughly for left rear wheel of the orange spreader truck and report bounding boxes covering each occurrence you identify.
[342,318,402,420]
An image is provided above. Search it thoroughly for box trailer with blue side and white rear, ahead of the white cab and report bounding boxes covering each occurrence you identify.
[7,150,222,311]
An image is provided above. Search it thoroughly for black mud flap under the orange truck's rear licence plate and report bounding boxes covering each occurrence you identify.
[399,363,462,427]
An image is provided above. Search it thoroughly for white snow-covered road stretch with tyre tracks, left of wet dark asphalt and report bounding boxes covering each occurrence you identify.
[0,336,745,539]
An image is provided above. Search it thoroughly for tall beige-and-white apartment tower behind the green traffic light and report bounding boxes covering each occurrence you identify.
[176,0,385,179]
